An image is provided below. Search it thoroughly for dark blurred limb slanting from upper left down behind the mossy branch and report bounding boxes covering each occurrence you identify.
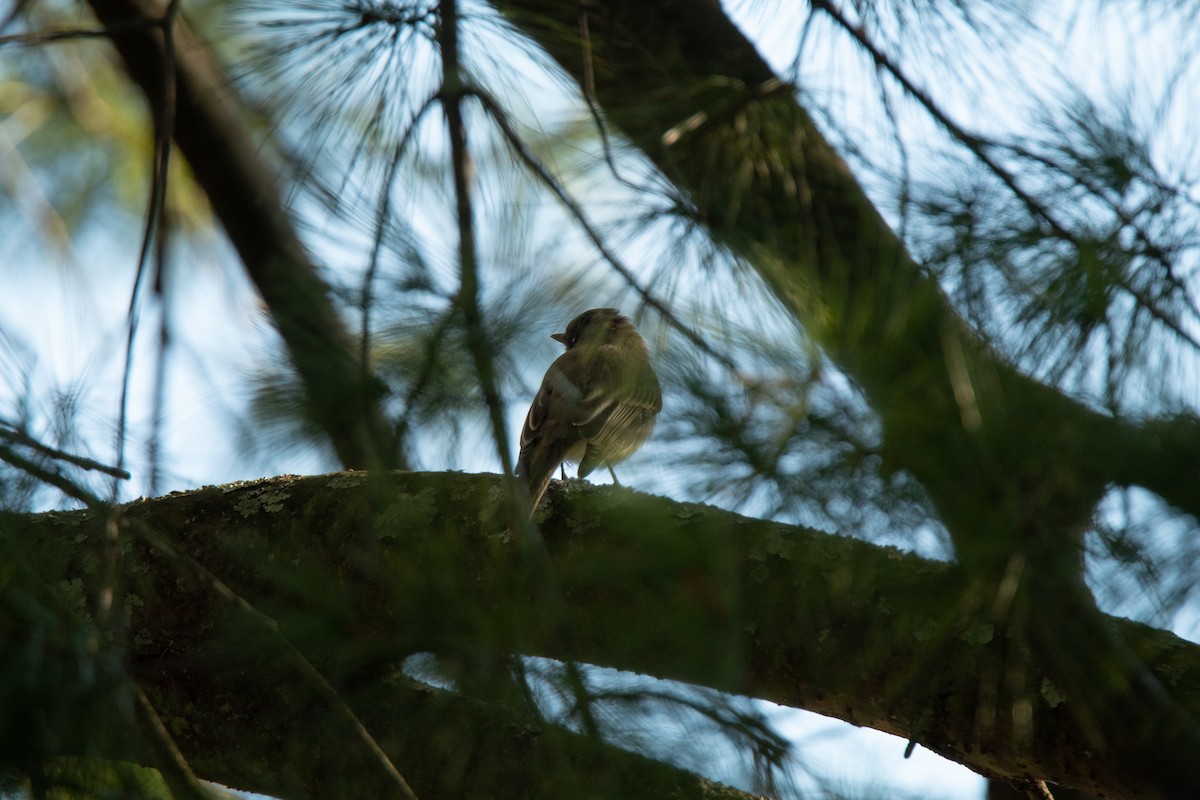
[90,0,402,468]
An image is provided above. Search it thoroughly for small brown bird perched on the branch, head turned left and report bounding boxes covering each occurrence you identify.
[516,308,662,515]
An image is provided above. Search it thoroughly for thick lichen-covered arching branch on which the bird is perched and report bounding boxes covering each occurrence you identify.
[12,474,1200,798]
